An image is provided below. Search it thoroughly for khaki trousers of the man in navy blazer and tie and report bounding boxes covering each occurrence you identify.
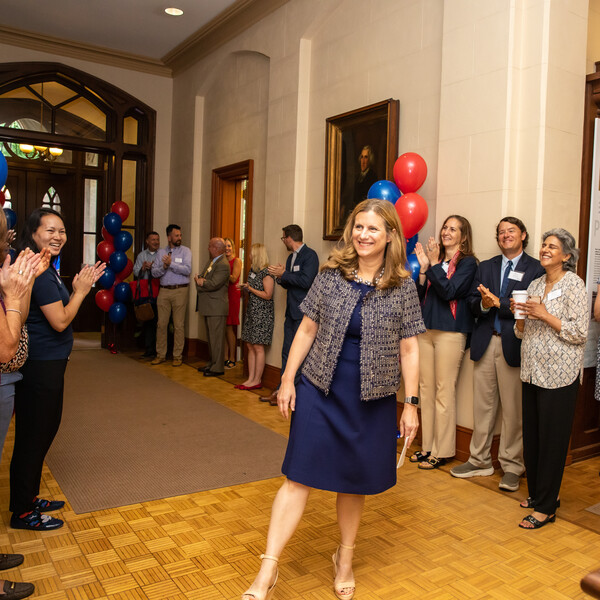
[469,335,525,475]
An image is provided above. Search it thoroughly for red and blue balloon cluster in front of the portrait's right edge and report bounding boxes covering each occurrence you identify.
[367,152,429,281]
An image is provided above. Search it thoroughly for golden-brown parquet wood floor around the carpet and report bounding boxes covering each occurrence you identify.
[0,354,600,600]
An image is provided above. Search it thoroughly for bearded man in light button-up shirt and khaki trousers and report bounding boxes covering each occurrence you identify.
[150,224,192,367]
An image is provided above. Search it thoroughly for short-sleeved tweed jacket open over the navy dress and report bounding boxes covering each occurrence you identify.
[300,269,425,400]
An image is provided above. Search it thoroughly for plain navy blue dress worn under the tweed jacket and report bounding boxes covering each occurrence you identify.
[282,282,396,494]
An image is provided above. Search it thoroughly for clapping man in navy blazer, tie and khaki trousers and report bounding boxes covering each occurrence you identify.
[450,217,544,492]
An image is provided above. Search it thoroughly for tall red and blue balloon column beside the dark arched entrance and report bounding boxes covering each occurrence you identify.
[95,200,133,324]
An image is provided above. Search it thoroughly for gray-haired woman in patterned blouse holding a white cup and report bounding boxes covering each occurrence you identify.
[511,228,589,529]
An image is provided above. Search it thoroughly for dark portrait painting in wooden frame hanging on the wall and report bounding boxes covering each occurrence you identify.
[323,99,400,240]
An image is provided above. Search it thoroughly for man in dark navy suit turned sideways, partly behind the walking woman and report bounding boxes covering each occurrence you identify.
[260,225,319,406]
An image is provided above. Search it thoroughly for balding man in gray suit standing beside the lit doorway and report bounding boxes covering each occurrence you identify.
[194,238,230,377]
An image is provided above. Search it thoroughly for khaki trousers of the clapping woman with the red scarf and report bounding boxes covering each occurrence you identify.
[418,329,467,458]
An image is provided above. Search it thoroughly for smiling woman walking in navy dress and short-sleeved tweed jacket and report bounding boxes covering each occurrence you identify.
[242,199,425,600]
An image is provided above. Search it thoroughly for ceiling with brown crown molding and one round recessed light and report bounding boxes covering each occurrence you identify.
[0,0,287,76]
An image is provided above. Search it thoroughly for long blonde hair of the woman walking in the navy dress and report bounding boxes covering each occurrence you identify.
[321,198,410,290]
